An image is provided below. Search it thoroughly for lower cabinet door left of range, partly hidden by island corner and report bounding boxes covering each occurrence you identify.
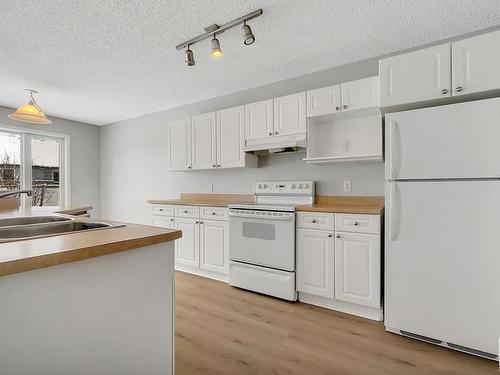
[175,218,200,267]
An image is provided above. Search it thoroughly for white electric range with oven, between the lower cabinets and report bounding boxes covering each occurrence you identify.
[229,181,315,301]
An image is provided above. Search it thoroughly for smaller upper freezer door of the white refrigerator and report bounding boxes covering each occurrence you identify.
[385,98,500,180]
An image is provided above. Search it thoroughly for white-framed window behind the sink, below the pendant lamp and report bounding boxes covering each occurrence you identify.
[0,129,69,207]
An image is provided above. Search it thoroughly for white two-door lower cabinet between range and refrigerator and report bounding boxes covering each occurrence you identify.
[296,212,382,320]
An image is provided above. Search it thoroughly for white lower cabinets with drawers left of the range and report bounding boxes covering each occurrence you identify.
[152,205,229,281]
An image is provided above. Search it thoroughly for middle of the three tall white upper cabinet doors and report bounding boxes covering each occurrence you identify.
[191,112,216,169]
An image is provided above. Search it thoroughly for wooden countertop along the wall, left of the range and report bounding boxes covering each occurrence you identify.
[148,193,255,207]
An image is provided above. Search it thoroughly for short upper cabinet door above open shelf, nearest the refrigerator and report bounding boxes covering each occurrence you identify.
[342,76,380,112]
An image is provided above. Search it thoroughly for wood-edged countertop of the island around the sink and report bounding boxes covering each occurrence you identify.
[0,210,182,276]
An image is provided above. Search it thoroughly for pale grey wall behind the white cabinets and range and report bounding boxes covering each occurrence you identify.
[101,59,384,224]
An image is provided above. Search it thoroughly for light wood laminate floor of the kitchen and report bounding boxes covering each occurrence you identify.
[175,272,498,375]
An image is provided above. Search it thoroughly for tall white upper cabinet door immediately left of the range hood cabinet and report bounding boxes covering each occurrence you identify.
[217,106,245,168]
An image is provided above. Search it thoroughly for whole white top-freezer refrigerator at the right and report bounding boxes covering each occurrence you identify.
[384,98,500,360]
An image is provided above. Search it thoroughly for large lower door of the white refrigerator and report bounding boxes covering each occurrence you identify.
[385,181,500,355]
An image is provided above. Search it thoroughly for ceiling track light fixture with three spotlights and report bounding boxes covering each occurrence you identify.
[175,9,262,66]
